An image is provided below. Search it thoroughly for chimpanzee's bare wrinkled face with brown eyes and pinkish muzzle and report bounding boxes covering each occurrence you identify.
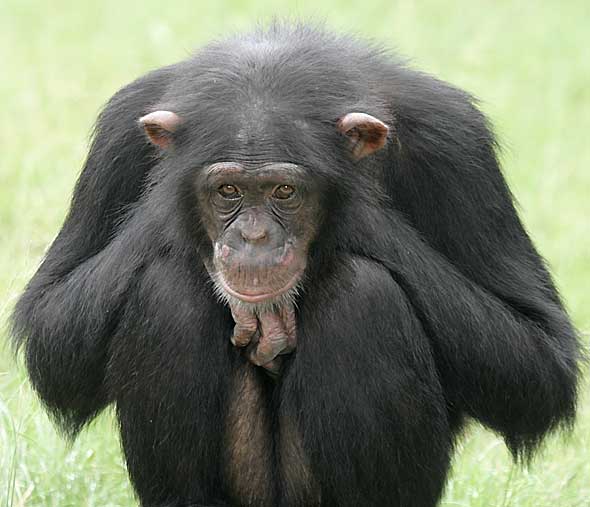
[196,162,320,305]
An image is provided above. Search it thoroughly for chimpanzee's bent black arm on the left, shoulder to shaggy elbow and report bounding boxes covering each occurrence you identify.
[13,69,171,433]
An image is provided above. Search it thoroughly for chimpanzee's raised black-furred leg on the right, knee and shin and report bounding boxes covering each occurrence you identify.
[279,254,451,507]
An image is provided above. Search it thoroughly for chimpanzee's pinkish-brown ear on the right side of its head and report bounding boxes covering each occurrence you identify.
[336,113,389,160]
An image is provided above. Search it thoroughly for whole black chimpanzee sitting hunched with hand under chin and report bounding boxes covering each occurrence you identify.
[13,24,580,507]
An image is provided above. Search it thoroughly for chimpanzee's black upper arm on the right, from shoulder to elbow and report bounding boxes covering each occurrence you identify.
[385,74,560,319]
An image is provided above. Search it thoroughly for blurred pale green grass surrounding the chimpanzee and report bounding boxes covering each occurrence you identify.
[0,0,590,507]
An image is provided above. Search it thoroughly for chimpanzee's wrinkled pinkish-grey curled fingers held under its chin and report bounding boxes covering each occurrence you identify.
[231,305,297,374]
